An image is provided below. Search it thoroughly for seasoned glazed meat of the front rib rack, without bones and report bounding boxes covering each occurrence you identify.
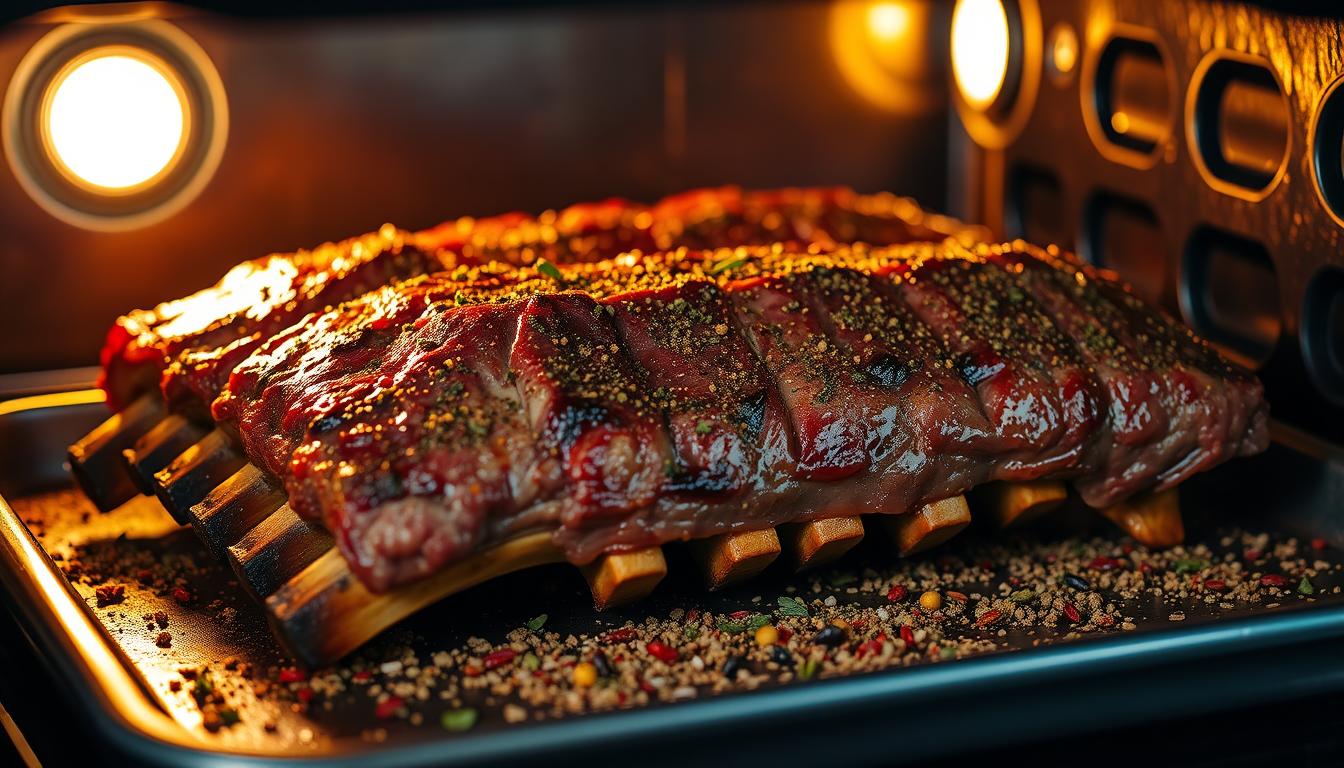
[214,242,1267,590]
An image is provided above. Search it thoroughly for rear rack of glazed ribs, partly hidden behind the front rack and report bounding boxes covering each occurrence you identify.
[101,188,960,416]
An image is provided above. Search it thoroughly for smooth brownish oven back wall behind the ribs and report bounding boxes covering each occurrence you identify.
[0,1,949,373]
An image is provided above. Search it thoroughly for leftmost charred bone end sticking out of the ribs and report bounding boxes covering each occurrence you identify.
[67,391,164,512]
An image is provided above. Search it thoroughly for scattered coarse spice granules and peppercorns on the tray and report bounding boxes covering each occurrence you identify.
[31,489,1344,742]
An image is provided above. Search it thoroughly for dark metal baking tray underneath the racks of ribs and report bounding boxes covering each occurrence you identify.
[0,390,1344,767]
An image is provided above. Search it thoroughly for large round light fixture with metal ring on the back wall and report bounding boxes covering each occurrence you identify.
[3,20,228,230]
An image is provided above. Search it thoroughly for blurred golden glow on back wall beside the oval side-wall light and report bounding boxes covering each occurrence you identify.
[829,0,942,114]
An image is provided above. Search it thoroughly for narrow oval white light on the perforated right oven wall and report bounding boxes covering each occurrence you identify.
[952,0,1011,109]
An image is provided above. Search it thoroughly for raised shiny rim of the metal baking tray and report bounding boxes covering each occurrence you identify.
[0,390,1344,765]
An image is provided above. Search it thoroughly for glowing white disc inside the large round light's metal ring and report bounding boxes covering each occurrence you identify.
[43,52,187,191]
